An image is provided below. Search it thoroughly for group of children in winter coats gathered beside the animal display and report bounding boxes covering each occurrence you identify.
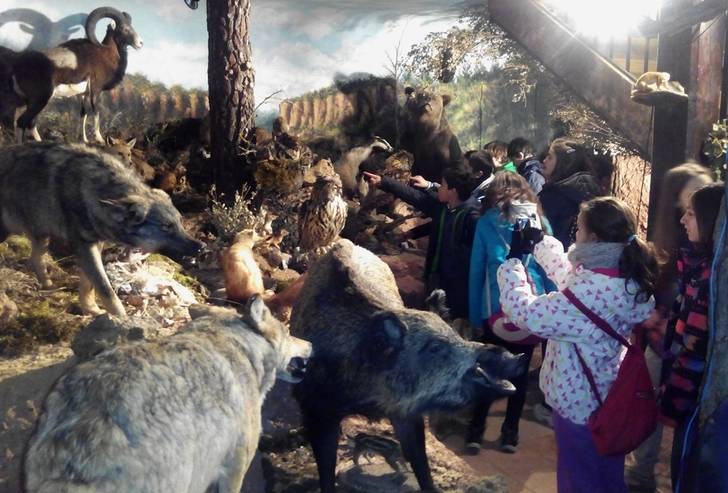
[366,138,724,492]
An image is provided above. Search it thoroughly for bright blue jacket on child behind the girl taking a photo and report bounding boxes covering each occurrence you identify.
[468,207,555,327]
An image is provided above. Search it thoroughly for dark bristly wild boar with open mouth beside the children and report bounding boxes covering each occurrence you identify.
[291,240,524,493]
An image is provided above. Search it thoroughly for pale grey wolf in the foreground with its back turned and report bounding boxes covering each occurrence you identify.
[24,296,311,493]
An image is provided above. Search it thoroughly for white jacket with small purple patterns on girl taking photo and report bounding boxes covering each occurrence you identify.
[498,236,654,424]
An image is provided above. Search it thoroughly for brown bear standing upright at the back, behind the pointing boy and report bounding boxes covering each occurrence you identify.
[402,87,463,183]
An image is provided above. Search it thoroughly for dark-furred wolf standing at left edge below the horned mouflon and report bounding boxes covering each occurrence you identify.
[0,139,202,315]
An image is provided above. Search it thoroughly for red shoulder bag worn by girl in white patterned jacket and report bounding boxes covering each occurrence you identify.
[562,289,657,455]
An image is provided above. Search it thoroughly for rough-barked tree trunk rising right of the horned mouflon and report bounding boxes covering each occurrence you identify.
[207,0,255,197]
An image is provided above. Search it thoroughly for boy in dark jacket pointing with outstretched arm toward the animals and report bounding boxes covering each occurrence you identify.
[364,167,478,318]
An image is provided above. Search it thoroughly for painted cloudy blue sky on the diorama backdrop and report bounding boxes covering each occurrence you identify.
[0,0,466,109]
